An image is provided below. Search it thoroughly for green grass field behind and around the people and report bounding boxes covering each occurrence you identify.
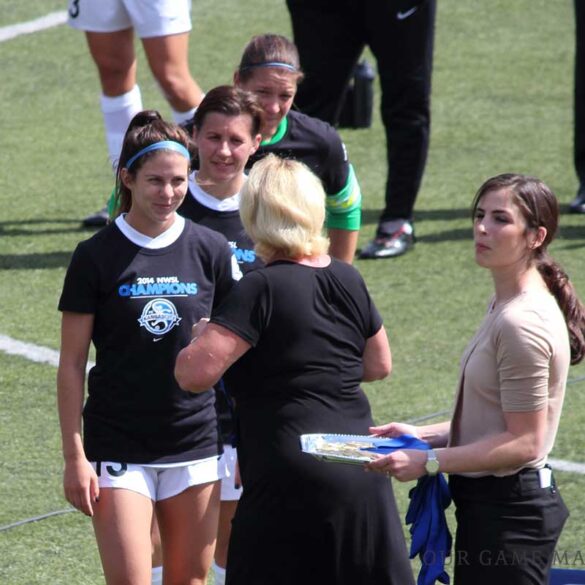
[0,0,585,585]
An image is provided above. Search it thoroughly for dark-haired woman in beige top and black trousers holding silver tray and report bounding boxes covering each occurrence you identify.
[369,174,585,585]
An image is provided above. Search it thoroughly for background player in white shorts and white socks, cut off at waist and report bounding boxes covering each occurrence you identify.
[68,0,203,227]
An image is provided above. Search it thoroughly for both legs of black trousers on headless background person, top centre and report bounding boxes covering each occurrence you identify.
[287,0,436,221]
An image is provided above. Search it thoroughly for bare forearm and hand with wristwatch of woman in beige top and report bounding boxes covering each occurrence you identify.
[368,408,547,481]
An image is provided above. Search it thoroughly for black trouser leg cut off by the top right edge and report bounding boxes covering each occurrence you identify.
[573,0,585,190]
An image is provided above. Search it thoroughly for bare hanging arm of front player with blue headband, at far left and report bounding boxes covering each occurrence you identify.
[57,312,99,516]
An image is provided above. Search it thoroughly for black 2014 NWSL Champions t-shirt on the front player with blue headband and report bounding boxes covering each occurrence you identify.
[59,221,233,464]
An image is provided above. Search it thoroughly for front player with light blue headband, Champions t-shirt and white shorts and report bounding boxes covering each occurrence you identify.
[58,112,237,583]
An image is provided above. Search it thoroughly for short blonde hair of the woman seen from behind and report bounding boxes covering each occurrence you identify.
[240,154,329,261]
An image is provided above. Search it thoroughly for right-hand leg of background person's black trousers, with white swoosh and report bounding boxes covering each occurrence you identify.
[366,0,436,225]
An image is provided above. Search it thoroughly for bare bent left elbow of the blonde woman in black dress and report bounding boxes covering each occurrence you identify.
[175,323,251,392]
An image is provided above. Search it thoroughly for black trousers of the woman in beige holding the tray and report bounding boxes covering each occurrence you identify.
[449,469,569,585]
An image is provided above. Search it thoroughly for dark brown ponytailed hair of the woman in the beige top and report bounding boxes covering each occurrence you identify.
[472,173,585,364]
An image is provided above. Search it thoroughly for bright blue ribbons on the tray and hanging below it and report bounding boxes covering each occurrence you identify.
[363,435,452,585]
